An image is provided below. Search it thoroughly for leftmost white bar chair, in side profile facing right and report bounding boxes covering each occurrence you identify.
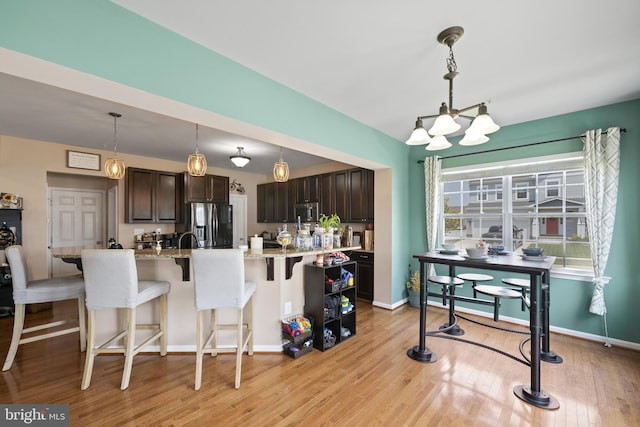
[2,245,86,371]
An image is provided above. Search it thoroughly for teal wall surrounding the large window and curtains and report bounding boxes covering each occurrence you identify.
[410,99,640,343]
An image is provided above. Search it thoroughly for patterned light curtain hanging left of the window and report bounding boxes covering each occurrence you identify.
[424,156,442,275]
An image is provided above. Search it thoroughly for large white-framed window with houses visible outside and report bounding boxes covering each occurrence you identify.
[440,155,593,274]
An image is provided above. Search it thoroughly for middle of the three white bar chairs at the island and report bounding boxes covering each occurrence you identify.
[81,249,171,390]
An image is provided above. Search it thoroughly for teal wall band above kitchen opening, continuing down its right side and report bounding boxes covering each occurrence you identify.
[0,0,410,301]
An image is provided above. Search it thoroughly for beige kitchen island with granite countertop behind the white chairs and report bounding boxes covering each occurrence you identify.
[51,246,360,352]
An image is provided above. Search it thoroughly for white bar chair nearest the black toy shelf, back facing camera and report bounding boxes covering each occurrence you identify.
[191,249,256,390]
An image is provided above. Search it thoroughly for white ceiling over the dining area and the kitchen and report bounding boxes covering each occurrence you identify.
[0,0,640,174]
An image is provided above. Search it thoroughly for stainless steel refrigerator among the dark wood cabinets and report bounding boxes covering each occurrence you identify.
[176,203,233,248]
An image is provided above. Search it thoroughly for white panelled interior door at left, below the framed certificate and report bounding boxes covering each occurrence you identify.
[49,188,105,277]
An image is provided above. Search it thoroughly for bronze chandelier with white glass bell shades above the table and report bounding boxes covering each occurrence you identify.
[406,27,500,151]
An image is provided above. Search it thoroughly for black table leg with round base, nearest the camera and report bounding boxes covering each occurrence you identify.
[513,274,560,409]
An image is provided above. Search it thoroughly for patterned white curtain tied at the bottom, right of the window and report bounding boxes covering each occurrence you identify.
[582,128,620,318]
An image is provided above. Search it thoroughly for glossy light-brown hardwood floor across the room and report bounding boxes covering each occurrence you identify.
[0,301,640,426]
